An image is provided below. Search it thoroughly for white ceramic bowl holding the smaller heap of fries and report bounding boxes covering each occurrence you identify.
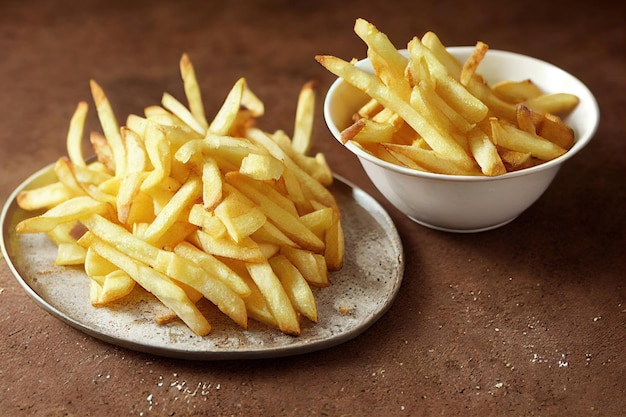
[324,46,600,232]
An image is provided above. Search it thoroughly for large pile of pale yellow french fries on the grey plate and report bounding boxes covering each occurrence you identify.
[16,54,344,336]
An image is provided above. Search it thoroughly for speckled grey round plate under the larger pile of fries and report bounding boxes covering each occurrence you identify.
[1,166,404,360]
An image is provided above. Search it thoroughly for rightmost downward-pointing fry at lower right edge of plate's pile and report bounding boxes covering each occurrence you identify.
[269,255,317,322]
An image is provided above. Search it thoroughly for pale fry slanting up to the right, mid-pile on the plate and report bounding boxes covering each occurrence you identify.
[142,175,202,242]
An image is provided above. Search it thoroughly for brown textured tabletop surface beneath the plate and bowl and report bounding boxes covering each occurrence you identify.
[0,0,626,416]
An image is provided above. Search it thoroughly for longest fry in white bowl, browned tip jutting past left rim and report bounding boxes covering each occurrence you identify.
[316,56,475,169]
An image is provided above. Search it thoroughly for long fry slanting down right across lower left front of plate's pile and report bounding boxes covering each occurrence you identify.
[79,233,211,336]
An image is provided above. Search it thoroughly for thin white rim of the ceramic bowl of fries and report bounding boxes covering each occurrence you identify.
[323,46,600,182]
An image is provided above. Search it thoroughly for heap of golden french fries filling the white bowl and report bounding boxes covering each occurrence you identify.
[316,19,579,176]
